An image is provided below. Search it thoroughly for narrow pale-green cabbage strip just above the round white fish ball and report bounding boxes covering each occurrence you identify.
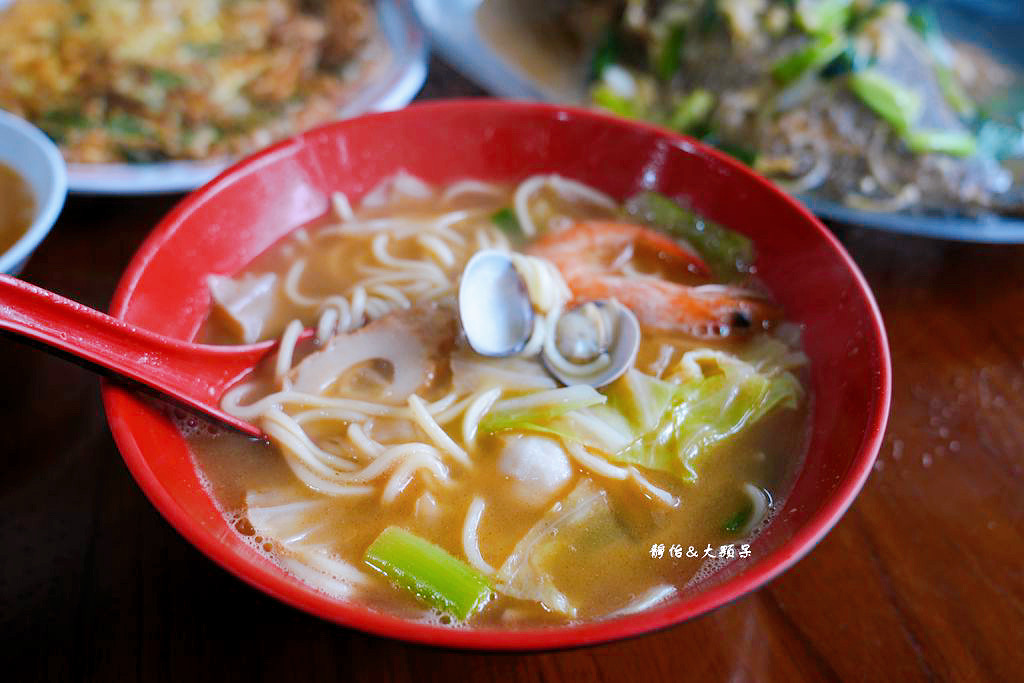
[478,385,606,435]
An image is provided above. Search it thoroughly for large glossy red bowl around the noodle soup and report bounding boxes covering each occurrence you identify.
[103,100,891,649]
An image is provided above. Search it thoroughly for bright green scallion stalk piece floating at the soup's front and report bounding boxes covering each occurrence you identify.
[362,526,492,621]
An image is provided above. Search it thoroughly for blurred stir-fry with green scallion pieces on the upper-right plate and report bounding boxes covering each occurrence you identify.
[566,0,1024,214]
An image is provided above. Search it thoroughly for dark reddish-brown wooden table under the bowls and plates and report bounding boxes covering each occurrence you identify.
[6,57,1024,682]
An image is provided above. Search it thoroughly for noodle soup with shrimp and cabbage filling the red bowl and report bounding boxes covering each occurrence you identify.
[186,173,809,629]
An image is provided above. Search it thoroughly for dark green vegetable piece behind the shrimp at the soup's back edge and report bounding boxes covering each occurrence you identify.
[625,191,754,280]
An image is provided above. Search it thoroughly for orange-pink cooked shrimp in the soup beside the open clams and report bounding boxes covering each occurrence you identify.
[530,221,780,339]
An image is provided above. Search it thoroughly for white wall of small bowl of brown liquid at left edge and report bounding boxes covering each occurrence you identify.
[0,111,68,275]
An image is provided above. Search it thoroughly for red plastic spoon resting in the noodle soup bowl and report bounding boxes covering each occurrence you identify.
[0,275,278,436]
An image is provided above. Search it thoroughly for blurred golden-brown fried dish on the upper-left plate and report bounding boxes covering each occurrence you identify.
[0,0,376,162]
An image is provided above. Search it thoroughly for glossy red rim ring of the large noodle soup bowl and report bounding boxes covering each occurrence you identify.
[102,98,892,651]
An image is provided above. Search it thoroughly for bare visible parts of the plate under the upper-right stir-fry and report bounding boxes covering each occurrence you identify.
[413,0,1024,243]
